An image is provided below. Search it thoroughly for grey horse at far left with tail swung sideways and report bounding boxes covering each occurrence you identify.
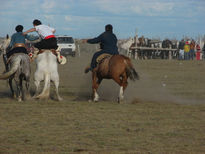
[0,36,31,101]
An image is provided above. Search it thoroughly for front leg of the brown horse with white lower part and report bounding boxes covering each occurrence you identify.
[92,71,102,102]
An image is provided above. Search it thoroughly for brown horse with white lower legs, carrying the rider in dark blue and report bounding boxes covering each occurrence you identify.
[92,55,139,103]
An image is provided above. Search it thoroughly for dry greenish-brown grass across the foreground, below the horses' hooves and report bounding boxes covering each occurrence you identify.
[0,101,205,153]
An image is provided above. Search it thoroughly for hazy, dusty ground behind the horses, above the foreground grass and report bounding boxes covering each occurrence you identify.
[0,41,205,104]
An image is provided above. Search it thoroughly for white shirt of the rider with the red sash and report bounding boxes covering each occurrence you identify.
[35,25,55,39]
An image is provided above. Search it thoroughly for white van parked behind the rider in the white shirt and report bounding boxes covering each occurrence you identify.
[56,35,76,57]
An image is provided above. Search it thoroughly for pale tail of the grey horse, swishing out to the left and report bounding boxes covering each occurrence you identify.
[0,58,21,80]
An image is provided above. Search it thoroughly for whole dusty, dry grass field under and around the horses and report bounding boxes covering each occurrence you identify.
[0,42,205,153]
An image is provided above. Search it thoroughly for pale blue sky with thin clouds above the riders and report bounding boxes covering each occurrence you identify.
[0,0,205,39]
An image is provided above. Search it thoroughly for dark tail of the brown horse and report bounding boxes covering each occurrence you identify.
[125,57,140,81]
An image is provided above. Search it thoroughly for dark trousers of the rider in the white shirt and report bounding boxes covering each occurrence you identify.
[34,37,58,50]
